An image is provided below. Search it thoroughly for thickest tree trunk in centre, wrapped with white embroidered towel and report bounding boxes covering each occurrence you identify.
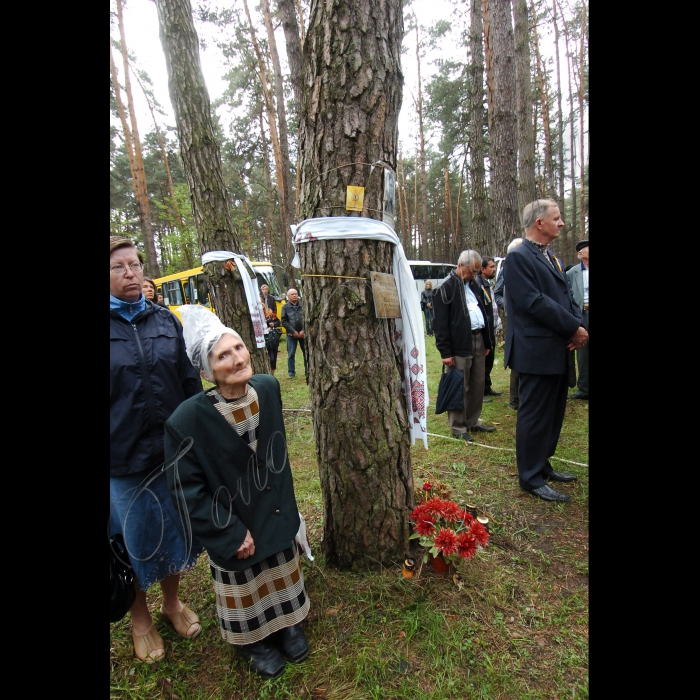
[299,0,413,568]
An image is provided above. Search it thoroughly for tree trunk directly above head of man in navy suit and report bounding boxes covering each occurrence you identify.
[516,0,537,215]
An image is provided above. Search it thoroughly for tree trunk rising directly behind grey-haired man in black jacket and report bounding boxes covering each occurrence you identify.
[468,0,488,252]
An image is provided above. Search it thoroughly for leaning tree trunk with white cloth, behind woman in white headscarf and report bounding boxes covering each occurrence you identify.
[156,0,270,372]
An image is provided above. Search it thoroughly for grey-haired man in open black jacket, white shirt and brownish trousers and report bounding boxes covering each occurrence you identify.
[433,250,495,442]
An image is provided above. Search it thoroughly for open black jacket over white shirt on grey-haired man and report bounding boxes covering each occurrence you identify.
[433,271,493,358]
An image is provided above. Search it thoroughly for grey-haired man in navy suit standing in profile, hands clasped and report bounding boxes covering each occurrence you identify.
[504,199,588,501]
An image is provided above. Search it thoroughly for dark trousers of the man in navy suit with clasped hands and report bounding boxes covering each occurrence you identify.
[515,372,568,489]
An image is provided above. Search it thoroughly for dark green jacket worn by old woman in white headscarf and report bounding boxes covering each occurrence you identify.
[165,374,299,571]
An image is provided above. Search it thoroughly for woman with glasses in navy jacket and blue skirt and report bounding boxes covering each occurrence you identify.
[109,236,202,663]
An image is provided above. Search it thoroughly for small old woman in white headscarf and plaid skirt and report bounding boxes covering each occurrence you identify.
[165,306,309,678]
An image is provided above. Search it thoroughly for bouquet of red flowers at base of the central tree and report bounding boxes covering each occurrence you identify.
[410,497,489,564]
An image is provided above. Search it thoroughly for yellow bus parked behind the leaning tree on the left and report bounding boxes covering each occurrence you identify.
[153,262,285,333]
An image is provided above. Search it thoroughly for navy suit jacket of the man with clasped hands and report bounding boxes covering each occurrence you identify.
[503,239,583,374]
